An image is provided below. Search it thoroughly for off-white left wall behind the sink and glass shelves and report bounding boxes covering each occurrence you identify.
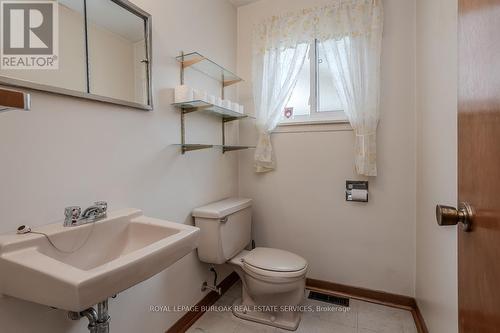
[0,0,238,333]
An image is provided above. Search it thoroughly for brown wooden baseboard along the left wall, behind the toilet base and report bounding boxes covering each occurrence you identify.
[166,272,240,333]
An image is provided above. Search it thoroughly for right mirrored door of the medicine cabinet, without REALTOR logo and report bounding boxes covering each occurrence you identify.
[87,0,149,104]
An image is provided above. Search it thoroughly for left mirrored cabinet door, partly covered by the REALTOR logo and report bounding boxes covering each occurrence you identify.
[0,0,87,92]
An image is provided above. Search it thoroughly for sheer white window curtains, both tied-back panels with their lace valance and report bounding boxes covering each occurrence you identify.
[253,0,383,176]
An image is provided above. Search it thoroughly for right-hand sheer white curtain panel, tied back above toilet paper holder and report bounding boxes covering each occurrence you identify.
[321,1,382,176]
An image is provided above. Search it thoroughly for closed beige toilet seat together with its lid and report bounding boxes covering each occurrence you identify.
[241,247,307,278]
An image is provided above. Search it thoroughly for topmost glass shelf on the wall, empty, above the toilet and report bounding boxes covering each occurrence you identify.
[175,52,243,87]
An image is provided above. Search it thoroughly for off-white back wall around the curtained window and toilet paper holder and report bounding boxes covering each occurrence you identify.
[238,0,416,296]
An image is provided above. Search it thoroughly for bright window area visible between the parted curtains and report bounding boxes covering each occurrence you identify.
[280,40,347,124]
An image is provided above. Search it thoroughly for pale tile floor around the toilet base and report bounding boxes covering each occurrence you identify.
[187,282,417,333]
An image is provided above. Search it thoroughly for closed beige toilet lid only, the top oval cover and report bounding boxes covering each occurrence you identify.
[242,247,307,272]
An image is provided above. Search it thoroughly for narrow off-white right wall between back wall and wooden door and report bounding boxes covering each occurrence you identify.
[416,0,458,333]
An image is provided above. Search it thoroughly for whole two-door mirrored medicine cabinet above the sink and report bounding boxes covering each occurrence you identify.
[0,0,152,110]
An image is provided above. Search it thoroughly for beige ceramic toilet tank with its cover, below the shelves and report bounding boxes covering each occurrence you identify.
[192,198,252,264]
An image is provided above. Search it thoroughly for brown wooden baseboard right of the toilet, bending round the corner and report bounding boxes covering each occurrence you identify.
[306,279,429,333]
